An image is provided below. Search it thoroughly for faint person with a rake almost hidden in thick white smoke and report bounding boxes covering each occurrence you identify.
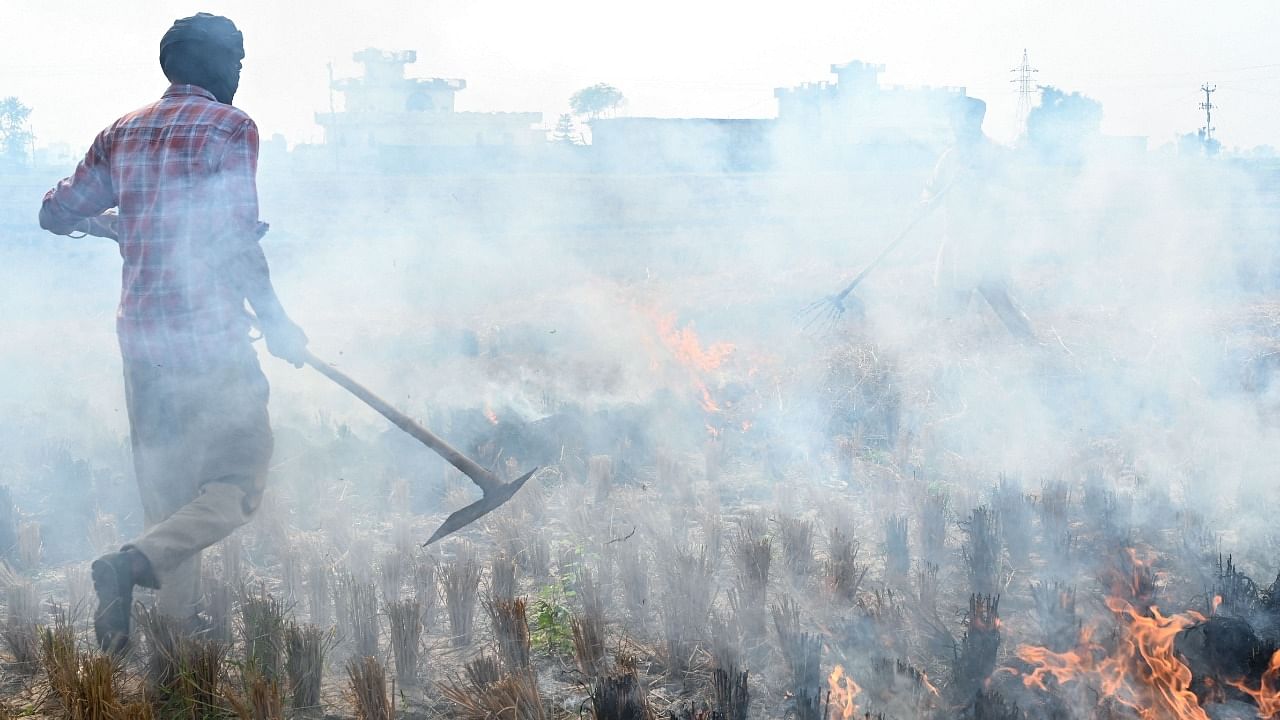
[924,97,1036,341]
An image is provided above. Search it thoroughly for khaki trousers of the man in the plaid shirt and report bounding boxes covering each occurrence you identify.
[124,342,273,620]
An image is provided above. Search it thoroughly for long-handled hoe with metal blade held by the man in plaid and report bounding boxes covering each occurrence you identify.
[306,352,538,546]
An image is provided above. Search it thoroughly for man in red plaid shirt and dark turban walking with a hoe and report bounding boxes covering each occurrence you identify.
[40,13,307,652]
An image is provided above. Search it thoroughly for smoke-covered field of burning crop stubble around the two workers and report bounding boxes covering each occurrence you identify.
[12,47,1280,720]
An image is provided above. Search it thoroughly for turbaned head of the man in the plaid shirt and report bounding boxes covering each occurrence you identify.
[160,13,244,105]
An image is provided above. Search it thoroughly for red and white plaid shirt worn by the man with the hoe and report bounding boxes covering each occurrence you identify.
[42,85,261,369]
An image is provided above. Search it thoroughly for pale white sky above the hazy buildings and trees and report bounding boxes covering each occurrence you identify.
[0,0,1280,147]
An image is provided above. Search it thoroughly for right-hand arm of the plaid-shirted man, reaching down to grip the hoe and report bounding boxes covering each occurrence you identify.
[218,120,307,368]
